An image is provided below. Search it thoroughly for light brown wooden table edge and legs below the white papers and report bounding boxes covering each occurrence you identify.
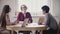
[6,25,45,34]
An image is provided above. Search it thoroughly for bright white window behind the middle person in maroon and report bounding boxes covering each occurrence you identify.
[18,0,48,16]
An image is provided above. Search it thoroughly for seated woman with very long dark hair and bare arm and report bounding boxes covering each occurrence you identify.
[1,5,11,34]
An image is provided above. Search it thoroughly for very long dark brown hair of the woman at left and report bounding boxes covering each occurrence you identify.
[1,5,10,28]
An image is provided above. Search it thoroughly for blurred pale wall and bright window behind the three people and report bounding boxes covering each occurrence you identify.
[0,0,60,22]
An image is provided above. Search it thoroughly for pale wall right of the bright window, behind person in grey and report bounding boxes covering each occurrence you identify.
[52,0,60,24]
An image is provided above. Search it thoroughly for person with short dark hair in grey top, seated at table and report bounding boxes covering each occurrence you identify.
[42,5,57,34]
